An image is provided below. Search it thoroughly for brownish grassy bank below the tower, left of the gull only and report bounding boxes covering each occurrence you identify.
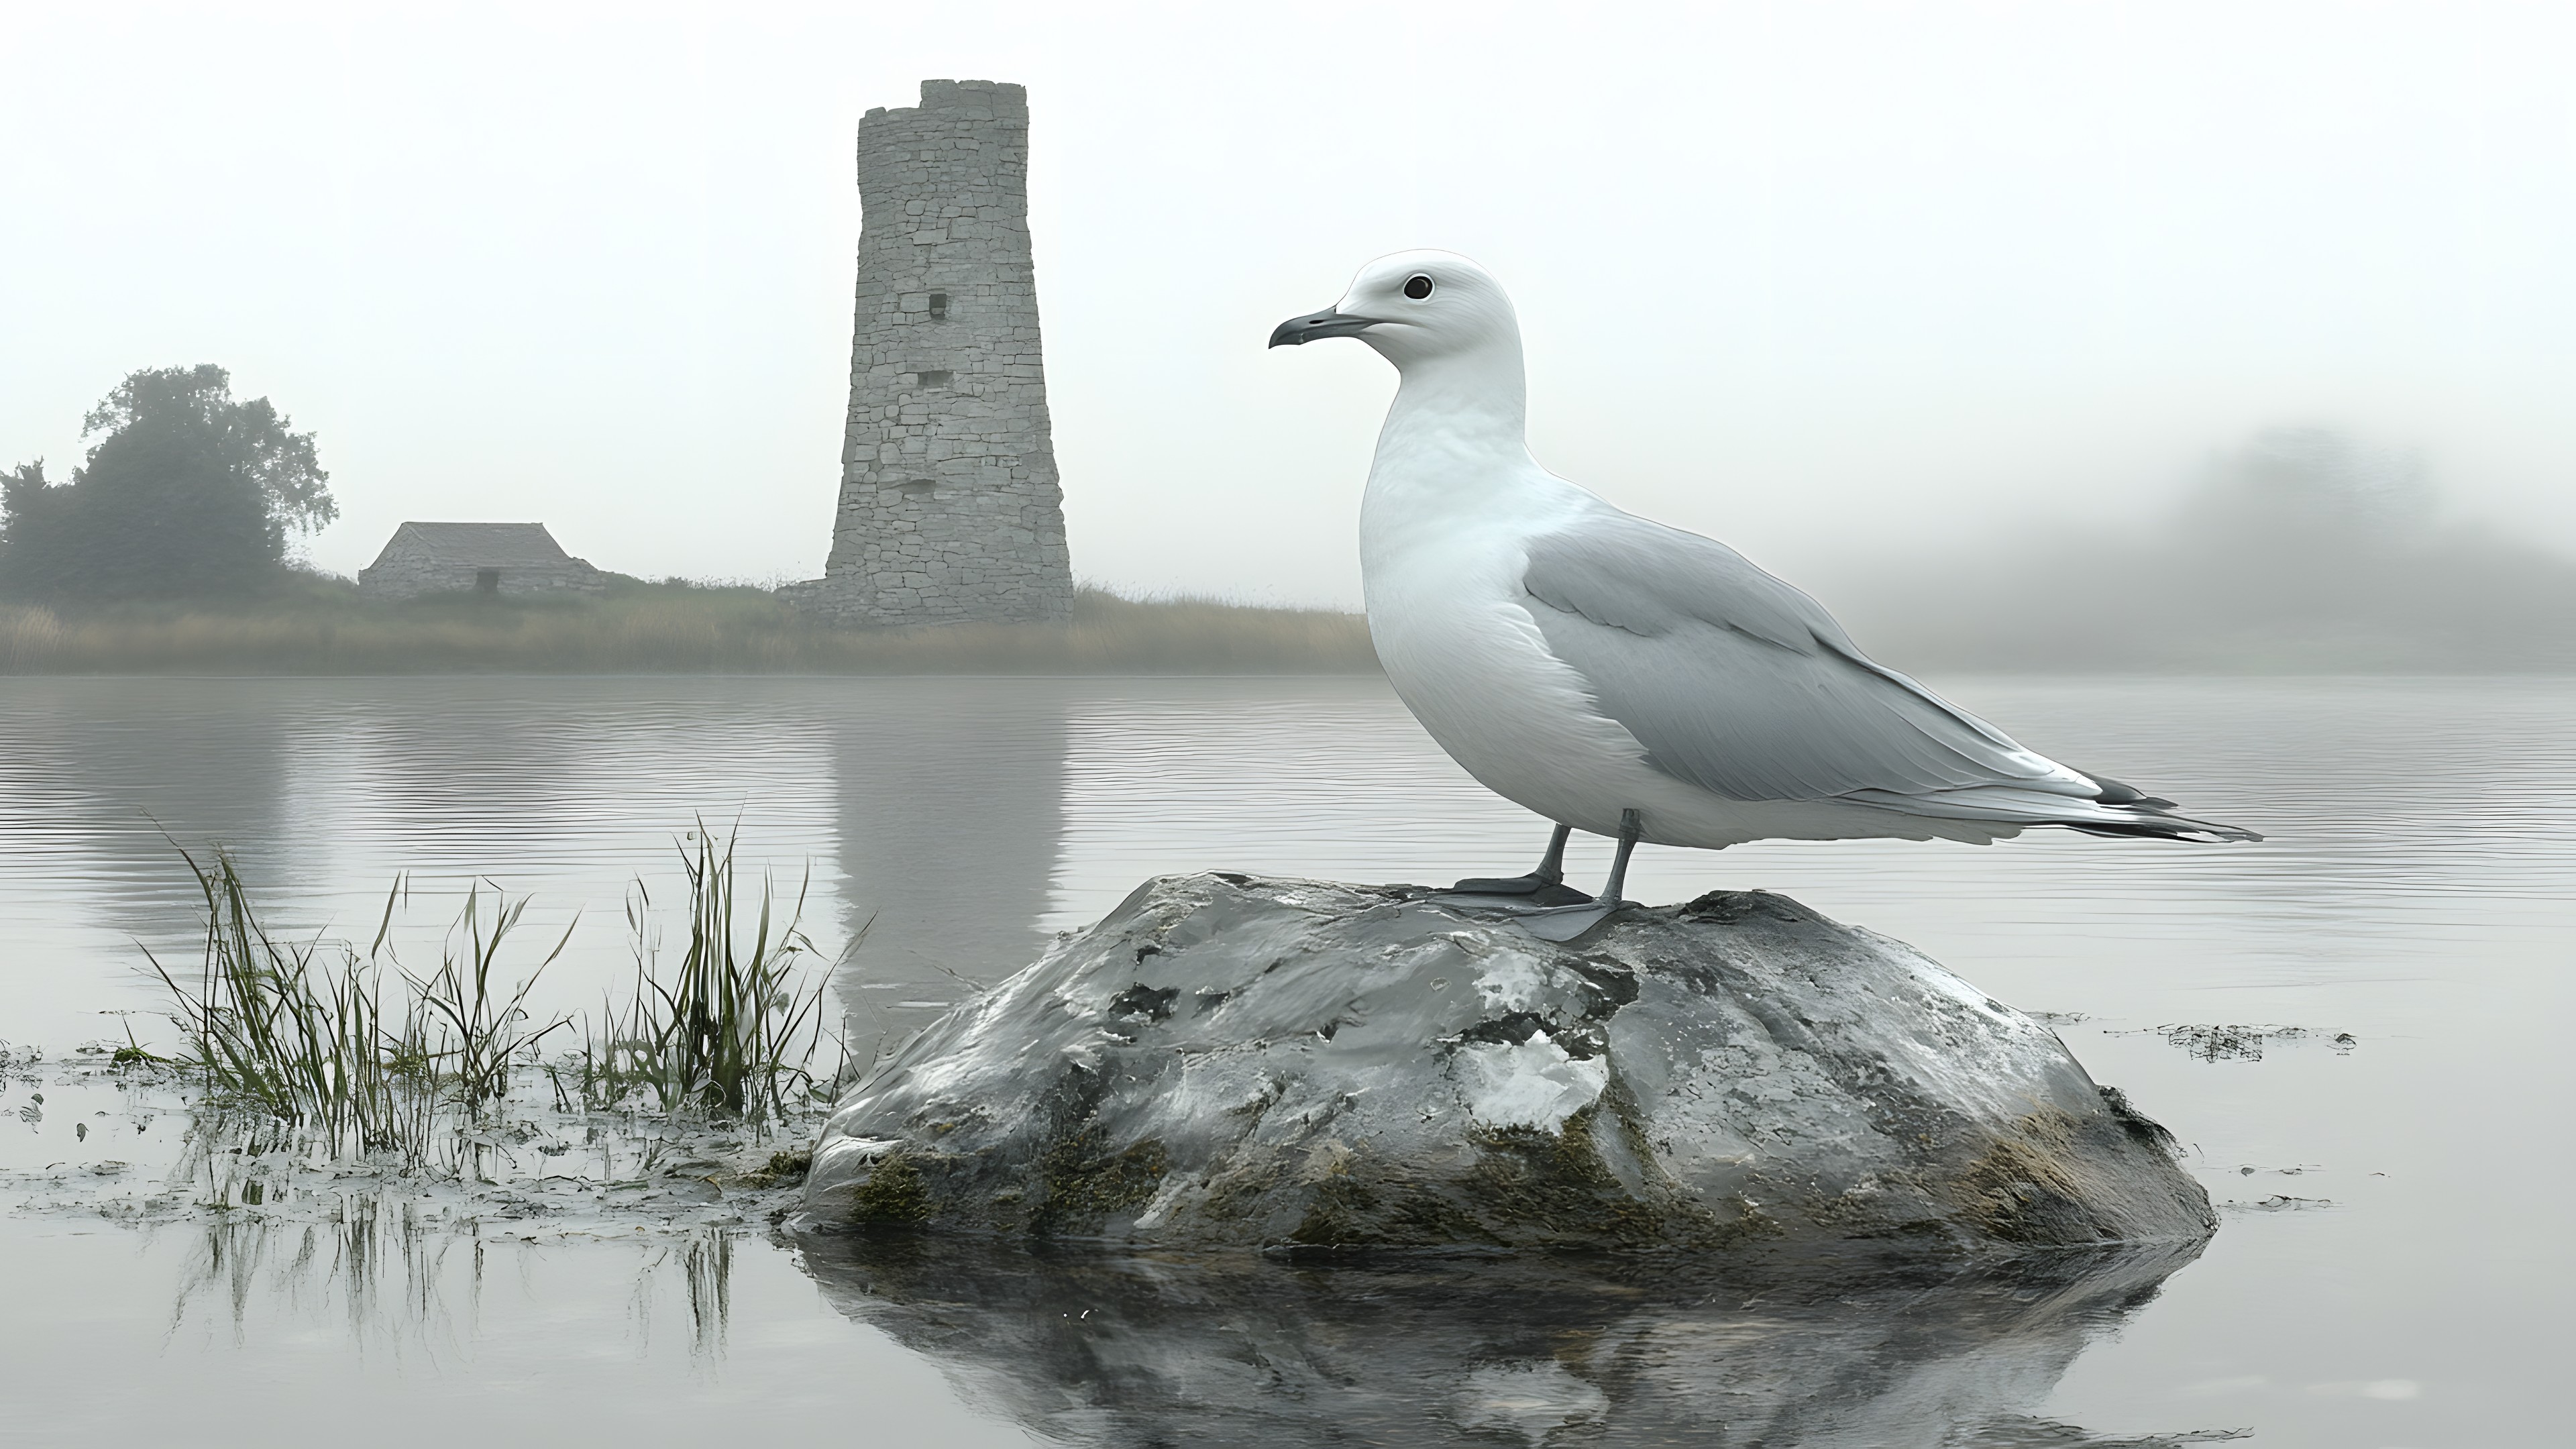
[0,580,1378,676]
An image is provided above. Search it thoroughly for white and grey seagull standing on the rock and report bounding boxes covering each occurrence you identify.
[1270,250,2259,938]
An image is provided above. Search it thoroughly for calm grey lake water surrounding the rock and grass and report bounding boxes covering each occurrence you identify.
[0,678,2576,1449]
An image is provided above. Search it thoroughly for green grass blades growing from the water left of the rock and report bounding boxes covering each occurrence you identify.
[148,822,837,1173]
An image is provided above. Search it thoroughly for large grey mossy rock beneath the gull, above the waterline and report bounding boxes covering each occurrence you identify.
[806,874,2215,1248]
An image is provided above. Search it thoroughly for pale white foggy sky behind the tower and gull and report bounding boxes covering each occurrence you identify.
[0,3,2576,603]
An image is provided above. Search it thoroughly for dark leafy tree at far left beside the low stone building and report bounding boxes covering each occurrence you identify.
[0,364,340,598]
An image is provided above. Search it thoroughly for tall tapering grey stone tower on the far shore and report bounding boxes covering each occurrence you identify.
[791,80,1074,624]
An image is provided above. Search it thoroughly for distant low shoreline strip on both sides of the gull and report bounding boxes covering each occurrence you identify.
[0,580,2576,678]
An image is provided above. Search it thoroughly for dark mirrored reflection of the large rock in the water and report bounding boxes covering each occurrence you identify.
[801,1235,2210,1449]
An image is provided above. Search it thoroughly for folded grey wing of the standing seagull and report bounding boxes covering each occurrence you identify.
[1522,513,2081,799]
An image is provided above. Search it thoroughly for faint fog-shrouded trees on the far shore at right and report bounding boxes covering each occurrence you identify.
[1811,428,2576,673]
